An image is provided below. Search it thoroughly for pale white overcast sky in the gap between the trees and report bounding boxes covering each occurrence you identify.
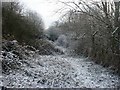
[20,0,70,28]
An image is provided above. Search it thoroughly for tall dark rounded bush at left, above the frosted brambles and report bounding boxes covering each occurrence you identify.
[2,2,44,44]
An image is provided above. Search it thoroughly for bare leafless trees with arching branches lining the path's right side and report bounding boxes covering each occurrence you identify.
[55,0,120,73]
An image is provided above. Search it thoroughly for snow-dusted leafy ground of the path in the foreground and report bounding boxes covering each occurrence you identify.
[4,56,120,88]
